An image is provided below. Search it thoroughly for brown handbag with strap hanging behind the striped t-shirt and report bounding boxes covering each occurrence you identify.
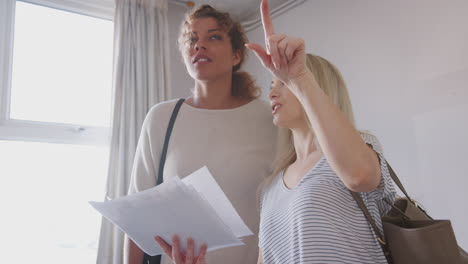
[351,161,468,264]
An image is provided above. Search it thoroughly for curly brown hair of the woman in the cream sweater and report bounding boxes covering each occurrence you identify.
[177,5,261,99]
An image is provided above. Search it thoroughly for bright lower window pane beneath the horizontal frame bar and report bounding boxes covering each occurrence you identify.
[0,141,108,264]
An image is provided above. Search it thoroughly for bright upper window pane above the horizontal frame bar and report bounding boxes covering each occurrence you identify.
[10,1,113,127]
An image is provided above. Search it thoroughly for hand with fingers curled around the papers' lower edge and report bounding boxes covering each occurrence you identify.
[154,235,207,264]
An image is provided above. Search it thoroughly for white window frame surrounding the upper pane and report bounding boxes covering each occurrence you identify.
[0,0,115,145]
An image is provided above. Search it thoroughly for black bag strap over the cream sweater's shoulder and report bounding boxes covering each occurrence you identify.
[143,98,185,264]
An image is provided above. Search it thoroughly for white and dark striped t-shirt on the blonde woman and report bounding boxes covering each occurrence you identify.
[259,133,395,264]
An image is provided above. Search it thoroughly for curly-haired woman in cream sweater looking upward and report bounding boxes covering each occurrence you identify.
[125,5,276,264]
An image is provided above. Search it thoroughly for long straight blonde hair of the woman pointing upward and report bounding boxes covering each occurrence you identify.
[266,54,354,184]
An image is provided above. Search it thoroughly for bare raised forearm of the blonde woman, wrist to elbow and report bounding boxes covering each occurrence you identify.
[288,72,380,191]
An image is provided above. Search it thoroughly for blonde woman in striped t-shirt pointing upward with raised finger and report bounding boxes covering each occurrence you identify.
[248,0,395,264]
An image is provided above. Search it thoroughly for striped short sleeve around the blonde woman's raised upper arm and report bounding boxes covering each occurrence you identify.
[360,132,395,208]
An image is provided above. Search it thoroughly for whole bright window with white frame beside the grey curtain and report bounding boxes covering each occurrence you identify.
[0,0,113,264]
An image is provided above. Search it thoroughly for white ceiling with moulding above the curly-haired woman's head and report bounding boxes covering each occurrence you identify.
[169,0,305,31]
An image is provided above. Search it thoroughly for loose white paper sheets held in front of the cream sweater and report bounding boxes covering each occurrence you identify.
[90,167,253,256]
